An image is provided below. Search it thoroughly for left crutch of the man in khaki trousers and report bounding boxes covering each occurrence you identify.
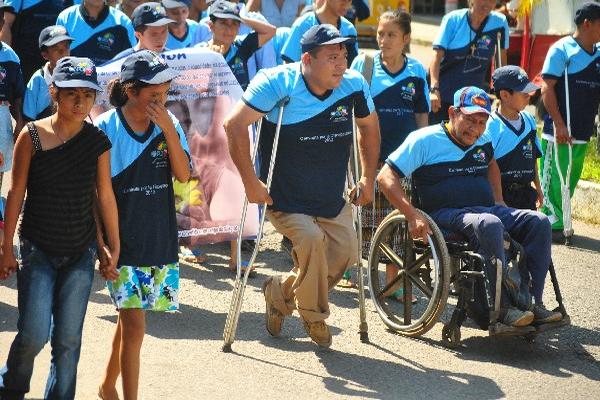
[223,97,288,353]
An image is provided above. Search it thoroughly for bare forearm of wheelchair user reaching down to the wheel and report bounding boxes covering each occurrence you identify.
[377,164,431,242]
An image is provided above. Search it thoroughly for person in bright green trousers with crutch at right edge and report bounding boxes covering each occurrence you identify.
[540,2,600,243]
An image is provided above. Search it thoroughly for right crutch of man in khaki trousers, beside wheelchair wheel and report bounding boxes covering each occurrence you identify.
[348,113,369,343]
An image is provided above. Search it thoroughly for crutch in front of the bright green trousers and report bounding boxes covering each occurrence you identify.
[553,60,573,246]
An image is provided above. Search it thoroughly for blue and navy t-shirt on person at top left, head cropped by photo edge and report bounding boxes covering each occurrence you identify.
[56,5,137,65]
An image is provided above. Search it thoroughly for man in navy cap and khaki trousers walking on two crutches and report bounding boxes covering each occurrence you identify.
[225,25,379,347]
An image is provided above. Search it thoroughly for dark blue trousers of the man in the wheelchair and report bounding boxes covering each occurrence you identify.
[431,206,552,303]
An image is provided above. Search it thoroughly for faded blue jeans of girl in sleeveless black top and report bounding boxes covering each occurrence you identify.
[0,240,96,400]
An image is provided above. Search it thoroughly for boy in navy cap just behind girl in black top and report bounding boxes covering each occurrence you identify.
[23,25,73,121]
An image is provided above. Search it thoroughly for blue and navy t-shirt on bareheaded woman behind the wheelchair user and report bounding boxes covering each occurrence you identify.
[350,52,429,161]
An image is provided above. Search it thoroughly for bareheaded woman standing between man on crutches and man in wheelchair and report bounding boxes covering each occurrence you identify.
[344,10,429,300]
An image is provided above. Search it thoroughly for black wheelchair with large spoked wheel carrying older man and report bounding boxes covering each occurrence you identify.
[367,182,570,348]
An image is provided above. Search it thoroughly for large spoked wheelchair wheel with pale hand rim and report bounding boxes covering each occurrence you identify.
[368,210,450,336]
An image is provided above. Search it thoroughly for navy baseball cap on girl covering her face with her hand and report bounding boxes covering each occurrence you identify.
[120,50,179,85]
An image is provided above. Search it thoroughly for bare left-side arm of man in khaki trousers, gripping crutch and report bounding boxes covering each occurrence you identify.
[223,101,273,205]
